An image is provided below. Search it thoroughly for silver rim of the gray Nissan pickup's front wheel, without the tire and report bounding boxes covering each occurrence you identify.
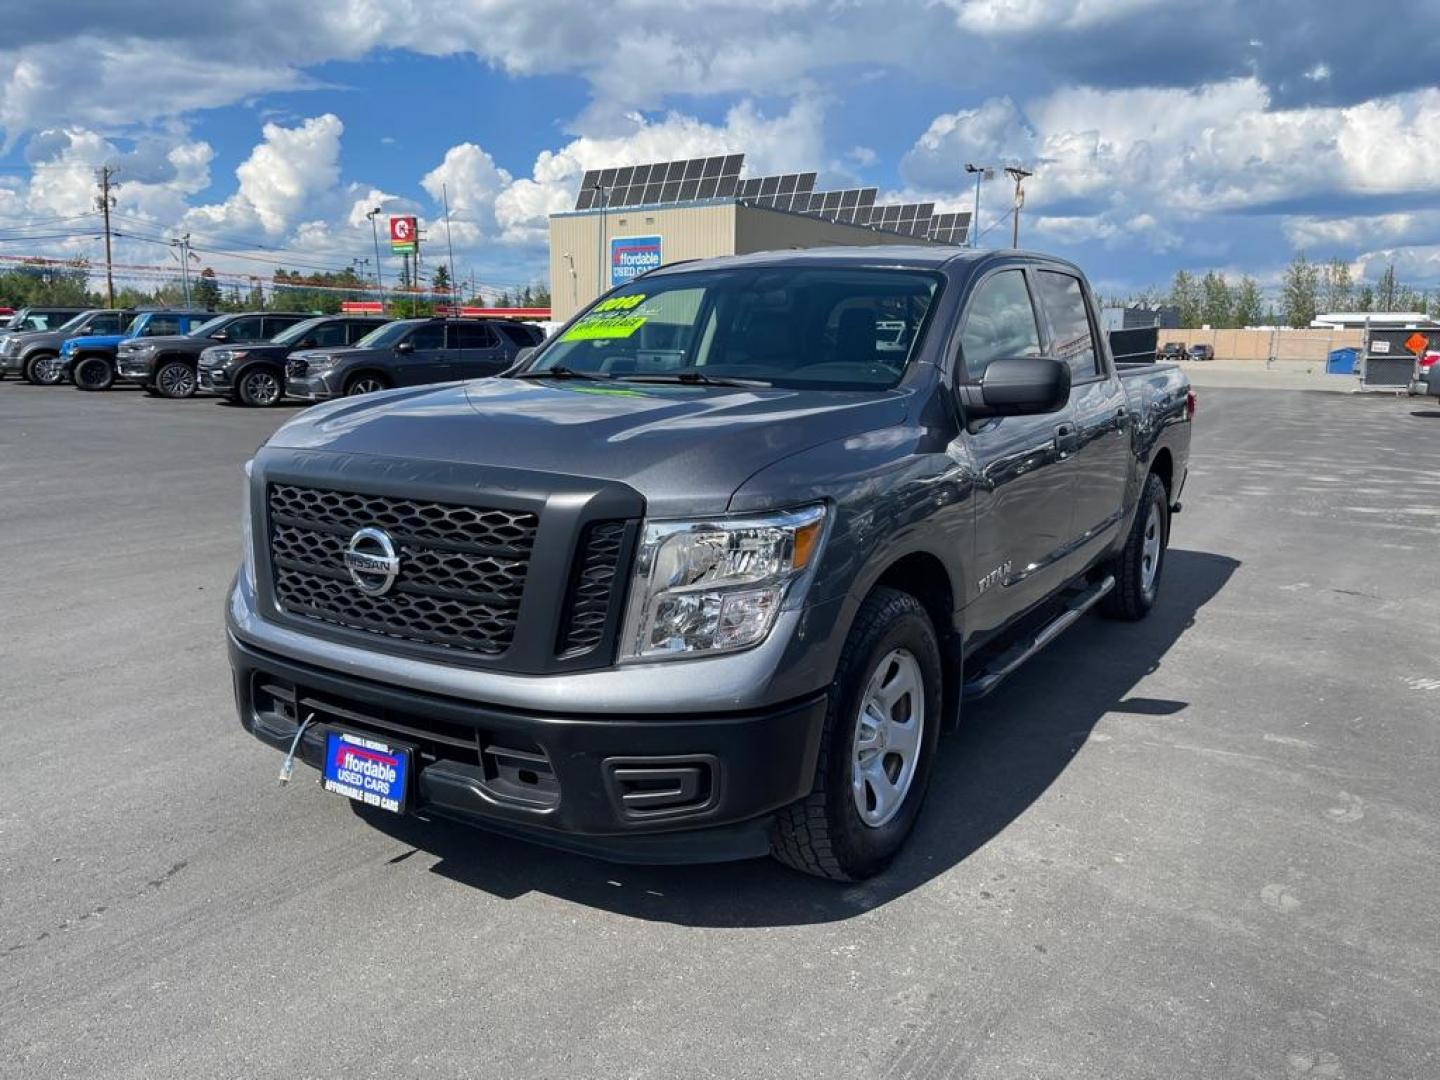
[850,649,924,828]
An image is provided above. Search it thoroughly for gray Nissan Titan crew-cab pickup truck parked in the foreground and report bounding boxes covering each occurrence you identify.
[226,248,1194,880]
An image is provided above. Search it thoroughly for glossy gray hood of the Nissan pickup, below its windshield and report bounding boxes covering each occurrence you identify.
[269,379,909,516]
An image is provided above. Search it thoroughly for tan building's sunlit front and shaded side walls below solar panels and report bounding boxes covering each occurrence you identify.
[550,203,944,321]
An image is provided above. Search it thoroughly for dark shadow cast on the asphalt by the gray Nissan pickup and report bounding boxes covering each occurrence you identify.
[364,550,1240,927]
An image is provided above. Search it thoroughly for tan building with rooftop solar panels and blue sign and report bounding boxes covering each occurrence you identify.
[550,154,971,320]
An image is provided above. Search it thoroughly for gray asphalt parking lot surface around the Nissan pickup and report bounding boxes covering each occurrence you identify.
[0,382,1440,1080]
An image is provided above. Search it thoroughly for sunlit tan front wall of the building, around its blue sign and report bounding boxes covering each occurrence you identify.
[550,203,736,321]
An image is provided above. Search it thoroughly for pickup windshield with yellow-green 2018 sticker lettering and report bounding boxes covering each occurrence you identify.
[528,266,940,390]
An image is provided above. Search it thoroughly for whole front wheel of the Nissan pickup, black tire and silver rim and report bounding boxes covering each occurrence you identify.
[770,588,940,881]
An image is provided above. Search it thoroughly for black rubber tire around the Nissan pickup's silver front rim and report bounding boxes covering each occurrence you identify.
[770,588,942,881]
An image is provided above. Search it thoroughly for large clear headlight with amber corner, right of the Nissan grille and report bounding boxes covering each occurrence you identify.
[621,505,825,660]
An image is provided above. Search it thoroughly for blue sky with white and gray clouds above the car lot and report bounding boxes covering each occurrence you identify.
[0,0,1440,300]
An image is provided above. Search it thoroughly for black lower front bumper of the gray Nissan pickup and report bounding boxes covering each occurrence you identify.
[229,635,827,863]
